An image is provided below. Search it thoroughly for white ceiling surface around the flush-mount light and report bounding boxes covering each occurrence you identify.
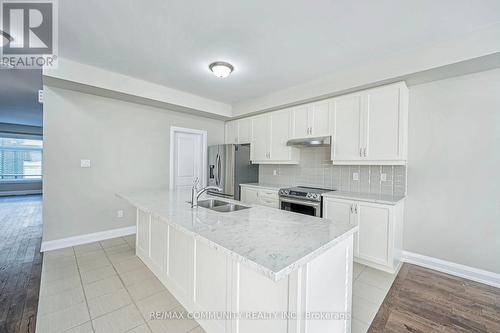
[59,0,500,103]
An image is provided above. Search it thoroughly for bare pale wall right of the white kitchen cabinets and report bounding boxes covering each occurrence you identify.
[404,70,500,273]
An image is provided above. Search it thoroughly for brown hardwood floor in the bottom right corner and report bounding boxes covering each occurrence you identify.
[368,264,500,333]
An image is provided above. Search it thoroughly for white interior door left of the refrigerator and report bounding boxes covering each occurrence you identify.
[173,131,203,189]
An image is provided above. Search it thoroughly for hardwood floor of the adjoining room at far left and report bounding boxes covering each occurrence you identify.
[0,195,42,333]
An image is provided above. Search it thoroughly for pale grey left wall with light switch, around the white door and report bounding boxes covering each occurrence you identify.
[43,86,224,241]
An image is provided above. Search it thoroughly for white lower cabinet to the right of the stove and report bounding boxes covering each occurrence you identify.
[323,198,404,273]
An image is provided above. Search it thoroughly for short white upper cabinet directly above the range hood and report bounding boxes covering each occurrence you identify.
[292,100,331,138]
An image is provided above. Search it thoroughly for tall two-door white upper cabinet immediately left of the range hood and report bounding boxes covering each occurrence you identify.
[250,110,299,164]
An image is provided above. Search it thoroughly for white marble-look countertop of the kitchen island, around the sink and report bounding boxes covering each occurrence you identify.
[118,190,357,281]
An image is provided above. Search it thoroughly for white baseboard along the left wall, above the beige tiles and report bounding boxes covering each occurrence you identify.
[40,225,136,252]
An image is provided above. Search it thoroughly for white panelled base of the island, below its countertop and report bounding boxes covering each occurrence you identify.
[136,210,353,333]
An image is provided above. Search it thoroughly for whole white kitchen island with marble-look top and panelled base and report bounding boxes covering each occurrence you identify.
[119,190,357,333]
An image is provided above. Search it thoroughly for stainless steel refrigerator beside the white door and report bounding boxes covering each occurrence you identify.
[208,144,259,200]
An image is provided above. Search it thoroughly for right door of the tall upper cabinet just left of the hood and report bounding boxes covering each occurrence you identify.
[270,110,292,161]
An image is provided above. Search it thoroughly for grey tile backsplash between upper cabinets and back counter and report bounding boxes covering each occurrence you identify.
[259,147,406,195]
